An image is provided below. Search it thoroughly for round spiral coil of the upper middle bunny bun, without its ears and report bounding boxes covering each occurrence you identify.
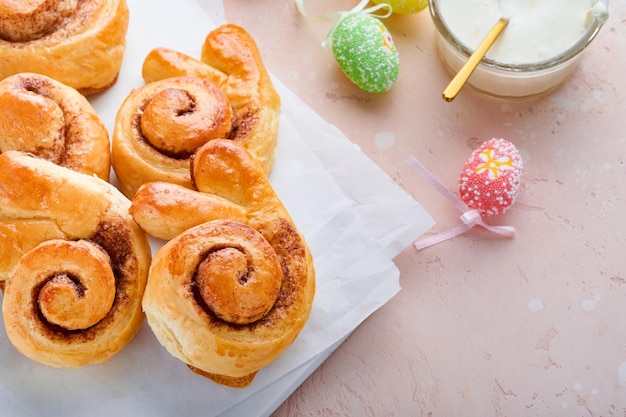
[112,77,232,198]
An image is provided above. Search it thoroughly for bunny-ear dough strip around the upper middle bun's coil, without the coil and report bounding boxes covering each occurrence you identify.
[142,24,280,174]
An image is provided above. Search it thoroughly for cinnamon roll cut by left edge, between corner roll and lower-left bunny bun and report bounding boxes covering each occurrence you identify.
[0,72,111,181]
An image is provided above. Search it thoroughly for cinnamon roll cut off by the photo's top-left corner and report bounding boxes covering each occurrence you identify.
[0,0,128,95]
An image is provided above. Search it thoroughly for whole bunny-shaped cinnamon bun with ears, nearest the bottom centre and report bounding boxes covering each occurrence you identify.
[131,139,315,387]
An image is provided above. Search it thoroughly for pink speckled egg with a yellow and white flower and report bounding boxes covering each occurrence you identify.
[459,138,523,216]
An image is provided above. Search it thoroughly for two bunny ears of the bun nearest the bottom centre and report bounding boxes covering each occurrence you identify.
[130,139,280,240]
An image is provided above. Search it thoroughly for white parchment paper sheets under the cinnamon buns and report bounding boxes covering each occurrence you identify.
[0,0,433,417]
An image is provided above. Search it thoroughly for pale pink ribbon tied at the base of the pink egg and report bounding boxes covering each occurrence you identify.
[407,156,515,250]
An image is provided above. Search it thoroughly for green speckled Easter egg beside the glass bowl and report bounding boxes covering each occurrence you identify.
[332,14,400,93]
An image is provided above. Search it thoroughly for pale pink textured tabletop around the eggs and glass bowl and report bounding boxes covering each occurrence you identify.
[224,0,626,417]
